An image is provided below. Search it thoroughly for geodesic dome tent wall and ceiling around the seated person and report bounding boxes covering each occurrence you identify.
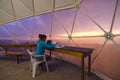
[0,0,120,80]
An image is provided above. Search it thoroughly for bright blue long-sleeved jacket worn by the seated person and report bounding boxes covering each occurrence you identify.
[35,40,55,55]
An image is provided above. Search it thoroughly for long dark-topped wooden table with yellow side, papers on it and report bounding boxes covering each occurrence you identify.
[54,46,94,80]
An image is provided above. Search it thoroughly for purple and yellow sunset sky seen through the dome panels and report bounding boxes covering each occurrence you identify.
[0,0,120,44]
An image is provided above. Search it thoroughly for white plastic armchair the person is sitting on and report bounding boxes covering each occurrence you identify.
[26,49,49,78]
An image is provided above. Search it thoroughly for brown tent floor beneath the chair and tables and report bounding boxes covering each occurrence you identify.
[0,56,102,80]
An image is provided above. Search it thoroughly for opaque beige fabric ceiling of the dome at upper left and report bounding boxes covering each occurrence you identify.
[0,0,82,25]
